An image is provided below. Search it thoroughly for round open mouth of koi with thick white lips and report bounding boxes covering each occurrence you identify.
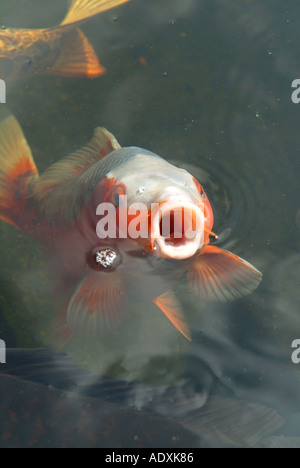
[151,198,205,260]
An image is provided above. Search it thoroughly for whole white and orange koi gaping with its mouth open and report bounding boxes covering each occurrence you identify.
[0,116,262,340]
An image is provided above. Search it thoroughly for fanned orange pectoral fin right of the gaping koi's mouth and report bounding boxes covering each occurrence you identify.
[188,246,262,302]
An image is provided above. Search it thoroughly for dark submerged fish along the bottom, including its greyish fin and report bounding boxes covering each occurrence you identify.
[0,350,284,448]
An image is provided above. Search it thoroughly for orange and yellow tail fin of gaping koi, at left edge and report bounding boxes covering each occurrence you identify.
[0,116,38,227]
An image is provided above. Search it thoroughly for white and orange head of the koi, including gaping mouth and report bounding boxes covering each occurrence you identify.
[100,148,213,260]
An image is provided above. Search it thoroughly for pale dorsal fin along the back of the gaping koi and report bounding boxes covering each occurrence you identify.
[35,128,121,198]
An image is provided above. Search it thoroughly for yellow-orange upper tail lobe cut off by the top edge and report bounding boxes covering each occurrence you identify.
[61,0,129,26]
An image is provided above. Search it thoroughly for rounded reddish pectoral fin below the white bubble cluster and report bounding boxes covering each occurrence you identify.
[67,272,127,339]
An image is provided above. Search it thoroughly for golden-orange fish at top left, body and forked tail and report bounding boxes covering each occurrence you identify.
[0,0,129,80]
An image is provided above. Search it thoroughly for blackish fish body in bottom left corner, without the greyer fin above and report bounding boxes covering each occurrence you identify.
[0,374,198,448]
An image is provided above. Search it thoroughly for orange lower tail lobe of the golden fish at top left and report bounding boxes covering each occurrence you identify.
[43,29,106,78]
